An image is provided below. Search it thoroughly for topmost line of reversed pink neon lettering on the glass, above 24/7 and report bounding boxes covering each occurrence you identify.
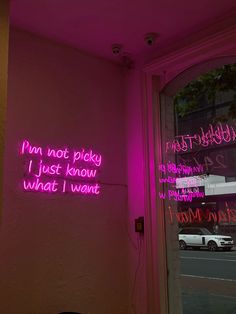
[166,123,236,153]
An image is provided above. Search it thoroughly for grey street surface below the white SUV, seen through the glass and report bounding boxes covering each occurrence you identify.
[180,247,236,314]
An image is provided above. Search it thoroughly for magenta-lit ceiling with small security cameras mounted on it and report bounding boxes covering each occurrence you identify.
[10,0,236,59]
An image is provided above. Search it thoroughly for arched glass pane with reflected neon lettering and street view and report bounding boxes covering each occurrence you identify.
[157,64,236,314]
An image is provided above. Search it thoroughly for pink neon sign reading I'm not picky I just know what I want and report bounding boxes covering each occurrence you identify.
[20,140,102,195]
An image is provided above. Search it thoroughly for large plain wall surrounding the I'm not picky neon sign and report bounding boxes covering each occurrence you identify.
[0,29,129,314]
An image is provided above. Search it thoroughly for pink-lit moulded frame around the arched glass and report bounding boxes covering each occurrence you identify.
[142,20,236,314]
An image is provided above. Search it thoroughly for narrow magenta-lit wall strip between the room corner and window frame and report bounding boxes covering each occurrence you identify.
[126,69,147,314]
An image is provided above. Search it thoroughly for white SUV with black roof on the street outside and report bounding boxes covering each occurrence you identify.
[179,227,234,251]
